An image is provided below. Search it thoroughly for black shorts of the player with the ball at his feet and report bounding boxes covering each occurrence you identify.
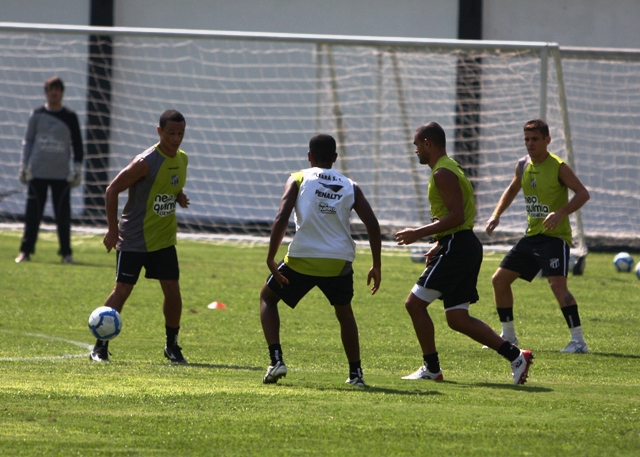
[116,246,180,284]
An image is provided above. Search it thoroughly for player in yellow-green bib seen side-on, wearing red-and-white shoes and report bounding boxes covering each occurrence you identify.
[396,122,534,384]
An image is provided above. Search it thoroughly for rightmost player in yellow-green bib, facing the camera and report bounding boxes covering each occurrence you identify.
[486,119,589,354]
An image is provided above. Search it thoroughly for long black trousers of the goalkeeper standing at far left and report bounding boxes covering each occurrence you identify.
[20,178,71,257]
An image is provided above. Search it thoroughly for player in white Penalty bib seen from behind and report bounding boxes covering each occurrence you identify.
[260,134,382,387]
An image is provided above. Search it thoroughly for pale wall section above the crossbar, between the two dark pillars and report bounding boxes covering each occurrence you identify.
[115,0,458,38]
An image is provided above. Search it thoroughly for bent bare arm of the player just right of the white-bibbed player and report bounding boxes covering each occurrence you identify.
[396,168,464,246]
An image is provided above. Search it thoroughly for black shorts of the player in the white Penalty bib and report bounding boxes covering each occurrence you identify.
[267,262,353,308]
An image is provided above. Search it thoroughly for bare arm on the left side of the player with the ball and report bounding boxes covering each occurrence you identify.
[102,157,149,252]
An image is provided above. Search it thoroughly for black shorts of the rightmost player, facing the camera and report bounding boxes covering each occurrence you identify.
[500,235,571,282]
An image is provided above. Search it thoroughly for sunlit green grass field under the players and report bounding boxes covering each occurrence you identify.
[0,231,640,457]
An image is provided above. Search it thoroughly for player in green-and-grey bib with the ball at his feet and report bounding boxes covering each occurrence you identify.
[90,110,189,363]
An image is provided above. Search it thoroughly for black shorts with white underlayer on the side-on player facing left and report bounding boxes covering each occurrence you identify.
[416,230,482,309]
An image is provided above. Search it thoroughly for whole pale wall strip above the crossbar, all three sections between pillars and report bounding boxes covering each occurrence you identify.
[5,0,640,48]
